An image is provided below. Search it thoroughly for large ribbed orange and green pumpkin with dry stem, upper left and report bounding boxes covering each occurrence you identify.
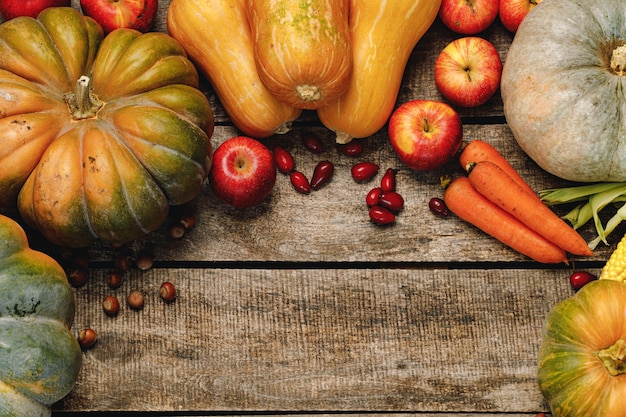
[0,7,214,247]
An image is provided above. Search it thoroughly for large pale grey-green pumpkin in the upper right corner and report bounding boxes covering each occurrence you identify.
[501,0,626,182]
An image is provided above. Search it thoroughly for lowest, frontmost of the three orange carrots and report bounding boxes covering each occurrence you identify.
[443,177,568,264]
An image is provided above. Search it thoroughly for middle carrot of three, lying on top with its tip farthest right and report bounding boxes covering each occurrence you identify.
[468,161,593,256]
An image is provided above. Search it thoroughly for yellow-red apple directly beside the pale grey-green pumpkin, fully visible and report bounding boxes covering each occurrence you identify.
[435,36,502,107]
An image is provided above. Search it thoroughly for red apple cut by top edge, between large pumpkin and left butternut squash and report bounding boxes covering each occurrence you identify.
[80,0,159,33]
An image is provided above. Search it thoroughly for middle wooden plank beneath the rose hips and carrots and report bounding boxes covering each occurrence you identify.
[74,124,621,263]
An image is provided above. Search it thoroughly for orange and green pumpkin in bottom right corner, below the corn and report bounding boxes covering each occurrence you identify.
[538,280,626,417]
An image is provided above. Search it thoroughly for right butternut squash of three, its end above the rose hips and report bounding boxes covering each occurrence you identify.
[317,0,441,143]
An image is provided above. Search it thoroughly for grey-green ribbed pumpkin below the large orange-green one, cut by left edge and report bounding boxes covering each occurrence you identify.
[0,215,82,417]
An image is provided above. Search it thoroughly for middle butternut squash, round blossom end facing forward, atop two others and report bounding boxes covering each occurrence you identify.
[248,0,352,110]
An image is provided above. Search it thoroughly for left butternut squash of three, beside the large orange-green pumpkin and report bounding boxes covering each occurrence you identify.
[167,0,302,138]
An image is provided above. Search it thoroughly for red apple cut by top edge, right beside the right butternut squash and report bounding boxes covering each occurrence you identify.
[439,0,500,35]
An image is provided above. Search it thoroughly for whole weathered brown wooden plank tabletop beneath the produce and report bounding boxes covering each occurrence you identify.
[3,0,623,417]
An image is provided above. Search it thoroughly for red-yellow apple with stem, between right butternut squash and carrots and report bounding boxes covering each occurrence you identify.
[389,100,463,171]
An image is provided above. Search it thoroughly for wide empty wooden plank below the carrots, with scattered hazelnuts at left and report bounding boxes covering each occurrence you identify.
[56,268,572,413]
